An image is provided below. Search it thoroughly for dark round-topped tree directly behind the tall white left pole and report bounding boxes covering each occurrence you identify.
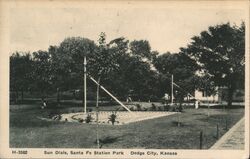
[49,37,97,106]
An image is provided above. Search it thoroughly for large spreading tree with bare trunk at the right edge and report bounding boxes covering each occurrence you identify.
[181,23,245,106]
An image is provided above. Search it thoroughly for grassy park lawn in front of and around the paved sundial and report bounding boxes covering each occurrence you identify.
[10,105,244,149]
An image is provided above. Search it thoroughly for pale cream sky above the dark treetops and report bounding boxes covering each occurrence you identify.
[10,2,245,53]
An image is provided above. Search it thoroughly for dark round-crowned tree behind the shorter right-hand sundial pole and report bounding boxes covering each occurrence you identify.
[153,52,198,102]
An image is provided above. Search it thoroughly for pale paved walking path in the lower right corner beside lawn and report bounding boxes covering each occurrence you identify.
[210,117,245,150]
